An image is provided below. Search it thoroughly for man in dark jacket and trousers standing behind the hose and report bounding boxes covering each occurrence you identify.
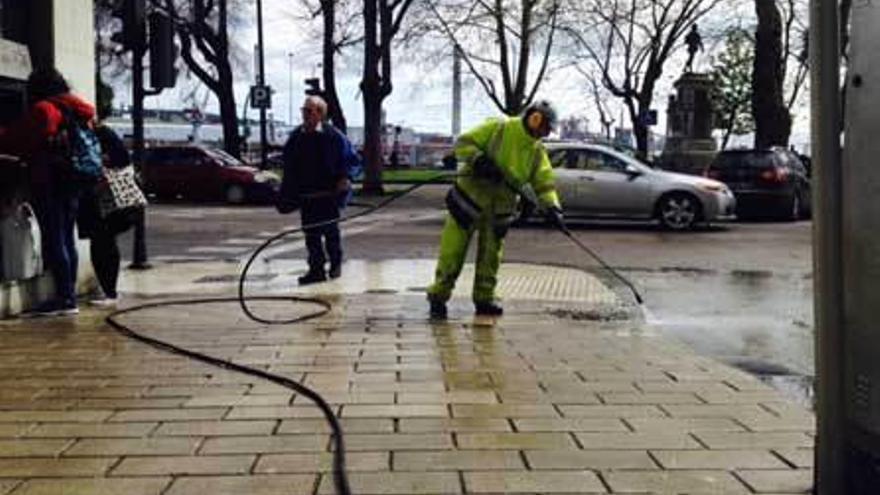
[278,96,360,285]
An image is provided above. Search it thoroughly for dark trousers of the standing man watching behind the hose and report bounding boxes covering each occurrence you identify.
[300,197,342,272]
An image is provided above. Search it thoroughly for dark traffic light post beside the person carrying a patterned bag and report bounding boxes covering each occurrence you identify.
[128,7,151,270]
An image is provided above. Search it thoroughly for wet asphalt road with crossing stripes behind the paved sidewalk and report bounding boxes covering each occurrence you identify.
[123,187,813,404]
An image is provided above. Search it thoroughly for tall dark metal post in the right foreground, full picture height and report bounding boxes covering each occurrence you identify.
[810,0,848,495]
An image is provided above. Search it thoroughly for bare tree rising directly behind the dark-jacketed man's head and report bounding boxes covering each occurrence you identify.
[302,0,363,132]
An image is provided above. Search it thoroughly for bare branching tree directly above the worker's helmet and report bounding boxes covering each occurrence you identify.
[429,0,561,115]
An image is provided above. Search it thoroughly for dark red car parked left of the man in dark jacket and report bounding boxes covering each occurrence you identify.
[143,146,281,204]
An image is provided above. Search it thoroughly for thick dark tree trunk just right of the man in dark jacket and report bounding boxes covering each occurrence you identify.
[361,0,422,194]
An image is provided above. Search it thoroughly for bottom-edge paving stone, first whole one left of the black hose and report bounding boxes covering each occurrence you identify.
[163,474,316,495]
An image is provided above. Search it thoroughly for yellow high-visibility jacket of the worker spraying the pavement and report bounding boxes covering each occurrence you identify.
[455,117,559,218]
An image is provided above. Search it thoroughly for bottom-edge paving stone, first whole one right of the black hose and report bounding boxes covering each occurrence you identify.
[464,471,607,493]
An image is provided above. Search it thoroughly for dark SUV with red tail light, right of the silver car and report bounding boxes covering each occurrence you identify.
[704,148,810,221]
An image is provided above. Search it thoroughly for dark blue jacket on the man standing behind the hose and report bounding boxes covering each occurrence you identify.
[280,124,360,208]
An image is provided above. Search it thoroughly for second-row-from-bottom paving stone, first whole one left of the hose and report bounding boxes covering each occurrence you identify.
[110,455,256,476]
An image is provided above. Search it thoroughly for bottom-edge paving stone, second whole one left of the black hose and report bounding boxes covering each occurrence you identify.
[14,478,171,495]
